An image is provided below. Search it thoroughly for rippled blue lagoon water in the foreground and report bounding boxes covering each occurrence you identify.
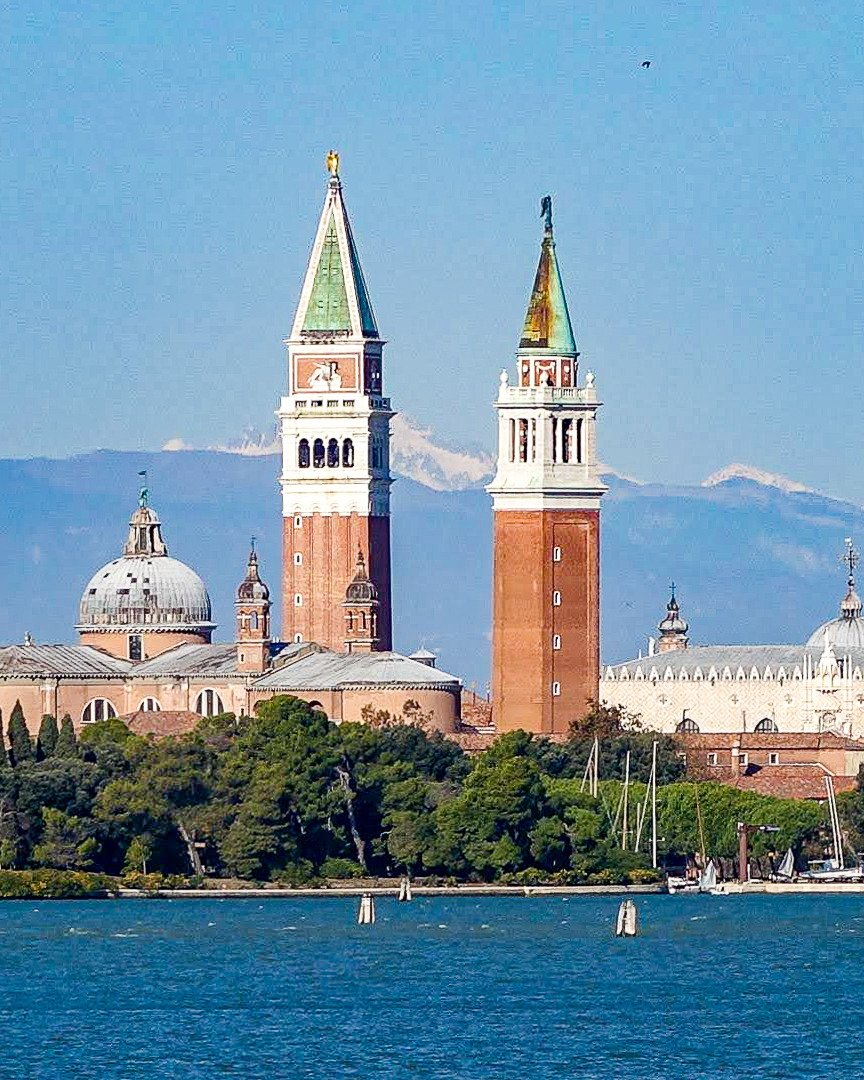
[0,895,864,1080]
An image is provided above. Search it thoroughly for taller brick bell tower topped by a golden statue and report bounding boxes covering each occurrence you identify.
[276,151,394,651]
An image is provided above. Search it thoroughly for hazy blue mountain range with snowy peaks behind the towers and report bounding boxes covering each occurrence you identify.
[0,421,864,688]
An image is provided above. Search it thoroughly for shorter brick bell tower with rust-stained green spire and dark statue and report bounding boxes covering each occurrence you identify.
[487,195,606,733]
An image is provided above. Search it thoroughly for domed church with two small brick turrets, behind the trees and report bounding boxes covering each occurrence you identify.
[0,496,461,733]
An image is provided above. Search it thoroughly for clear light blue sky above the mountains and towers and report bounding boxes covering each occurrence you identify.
[0,0,864,500]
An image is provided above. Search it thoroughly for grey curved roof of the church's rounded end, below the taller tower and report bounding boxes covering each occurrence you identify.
[255,651,461,690]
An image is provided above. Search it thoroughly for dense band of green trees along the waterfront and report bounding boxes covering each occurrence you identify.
[0,696,846,885]
